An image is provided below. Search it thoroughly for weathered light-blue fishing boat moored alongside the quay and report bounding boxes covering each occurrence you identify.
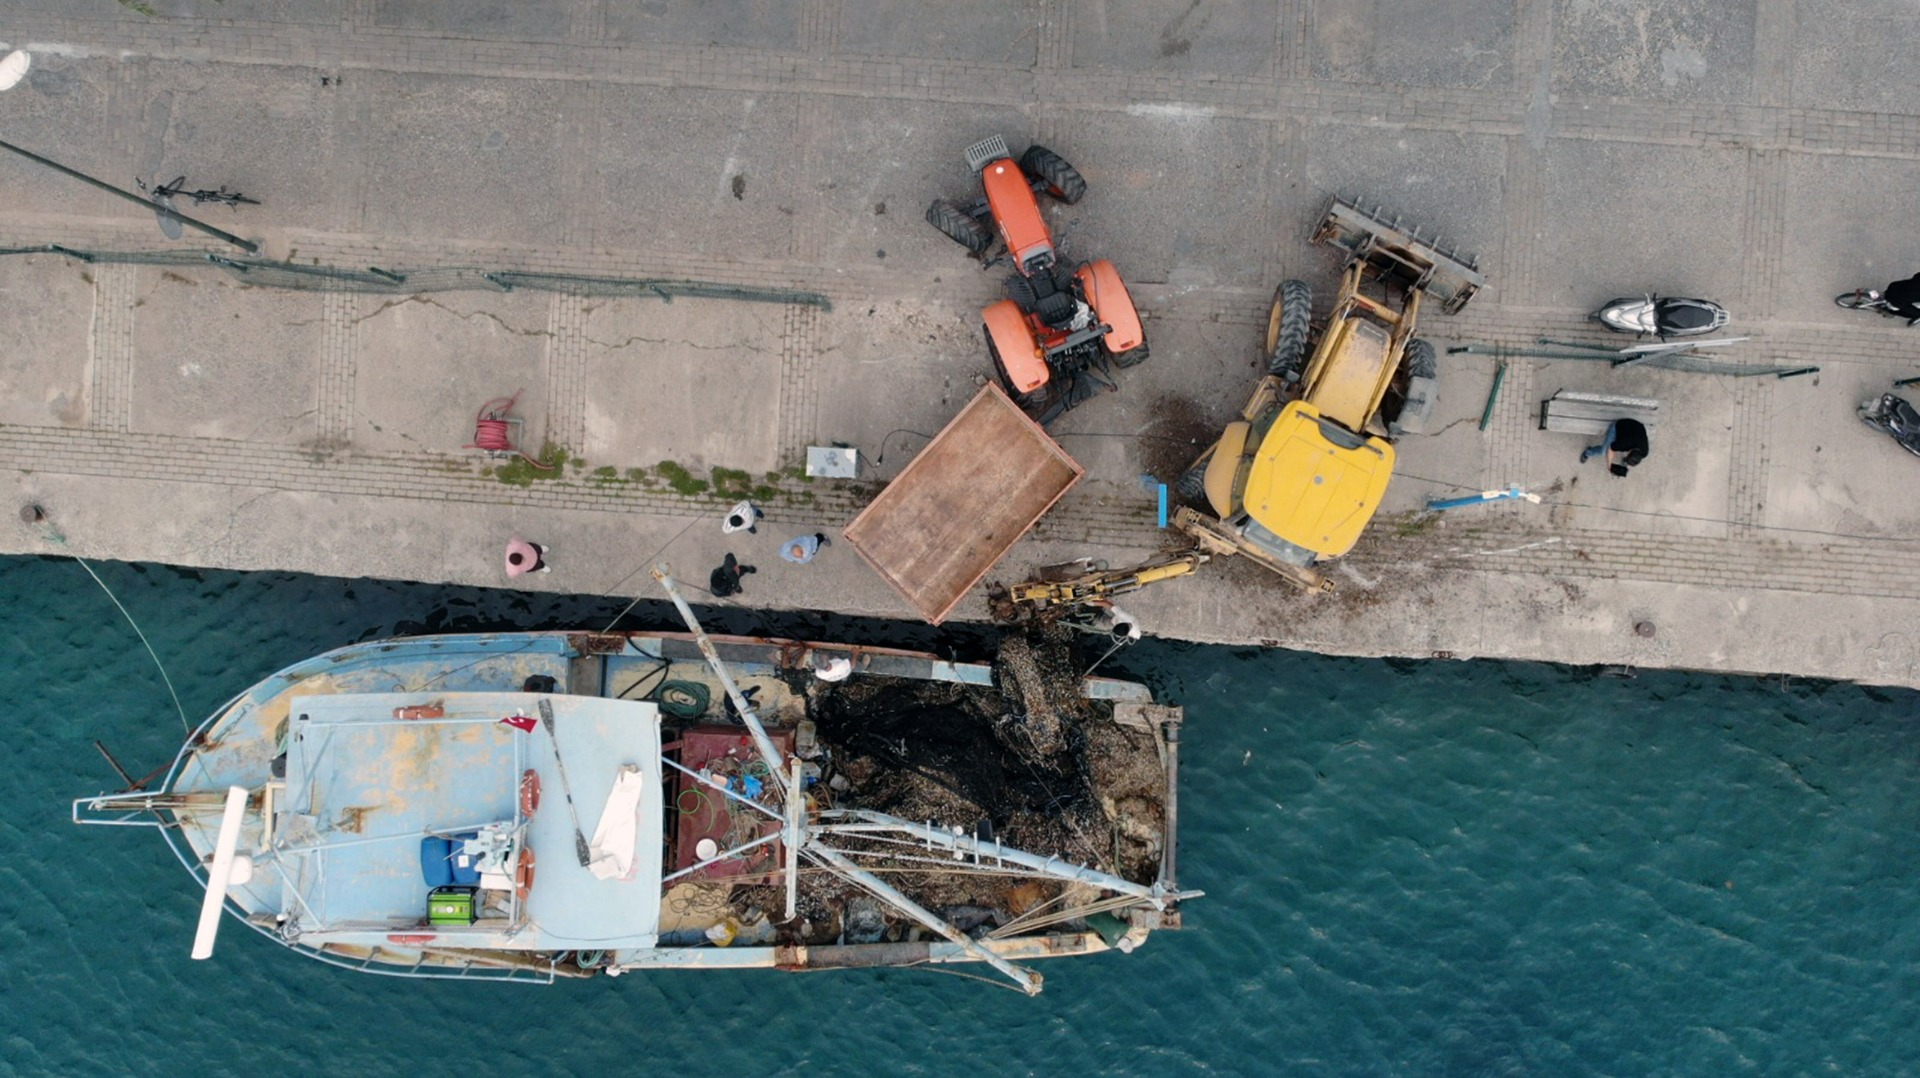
[73,565,1200,993]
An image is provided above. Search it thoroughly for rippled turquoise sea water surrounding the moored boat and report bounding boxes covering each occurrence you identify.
[0,557,1920,1078]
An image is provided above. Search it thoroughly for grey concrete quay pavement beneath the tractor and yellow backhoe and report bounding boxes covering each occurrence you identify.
[0,0,1920,686]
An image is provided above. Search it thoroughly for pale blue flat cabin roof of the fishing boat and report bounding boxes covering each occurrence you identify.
[273,692,664,951]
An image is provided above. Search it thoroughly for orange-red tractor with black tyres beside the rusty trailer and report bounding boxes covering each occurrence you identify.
[927,135,1146,427]
